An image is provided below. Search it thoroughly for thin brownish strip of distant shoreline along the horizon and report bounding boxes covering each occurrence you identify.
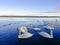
[0,16,60,18]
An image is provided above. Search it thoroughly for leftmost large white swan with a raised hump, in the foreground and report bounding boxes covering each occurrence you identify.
[18,26,33,39]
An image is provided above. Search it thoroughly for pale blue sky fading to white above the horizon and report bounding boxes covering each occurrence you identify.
[0,0,60,15]
